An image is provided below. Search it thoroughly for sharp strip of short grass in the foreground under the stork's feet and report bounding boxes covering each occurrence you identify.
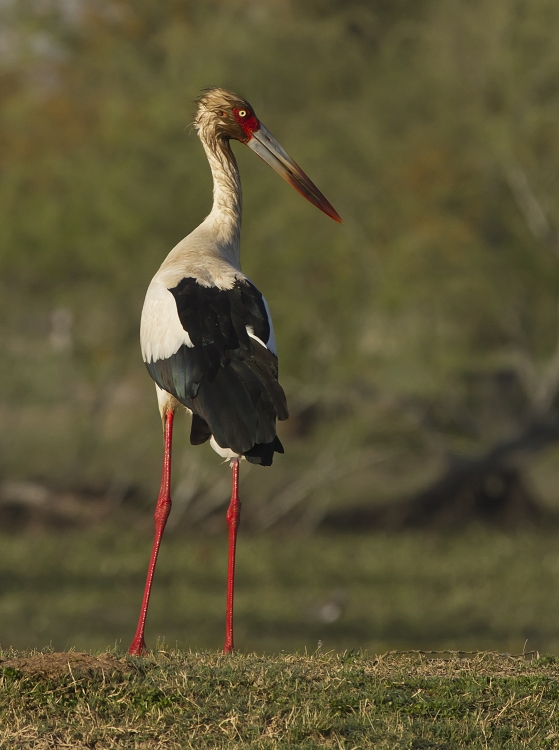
[0,651,559,750]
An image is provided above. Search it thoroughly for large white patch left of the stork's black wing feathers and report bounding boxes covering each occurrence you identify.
[140,280,194,362]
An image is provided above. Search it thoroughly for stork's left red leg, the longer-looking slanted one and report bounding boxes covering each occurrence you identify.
[128,409,174,656]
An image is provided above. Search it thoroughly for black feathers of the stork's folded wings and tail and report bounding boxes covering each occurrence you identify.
[147,278,288,466]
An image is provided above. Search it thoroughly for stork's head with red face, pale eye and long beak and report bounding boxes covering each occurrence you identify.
[194,88,342,223]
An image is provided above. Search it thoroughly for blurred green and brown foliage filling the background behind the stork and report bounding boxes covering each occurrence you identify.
[0,0,559,512]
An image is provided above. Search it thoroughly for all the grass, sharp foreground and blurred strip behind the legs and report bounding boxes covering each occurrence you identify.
[0,524,559,750]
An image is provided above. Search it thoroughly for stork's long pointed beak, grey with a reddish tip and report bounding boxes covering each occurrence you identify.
[247,123,342,224]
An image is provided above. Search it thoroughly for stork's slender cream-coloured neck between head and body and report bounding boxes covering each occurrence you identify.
[202,139,243,269]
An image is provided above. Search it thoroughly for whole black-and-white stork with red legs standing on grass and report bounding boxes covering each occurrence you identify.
[129,87,342,656]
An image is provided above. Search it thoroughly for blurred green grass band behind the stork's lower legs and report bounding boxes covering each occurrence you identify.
[0,525,559,654]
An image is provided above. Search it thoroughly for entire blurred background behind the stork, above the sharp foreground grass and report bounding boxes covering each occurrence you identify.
[0,0,559,652]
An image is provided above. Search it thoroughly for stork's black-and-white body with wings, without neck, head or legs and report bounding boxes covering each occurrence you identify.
[140,244,287,465]
